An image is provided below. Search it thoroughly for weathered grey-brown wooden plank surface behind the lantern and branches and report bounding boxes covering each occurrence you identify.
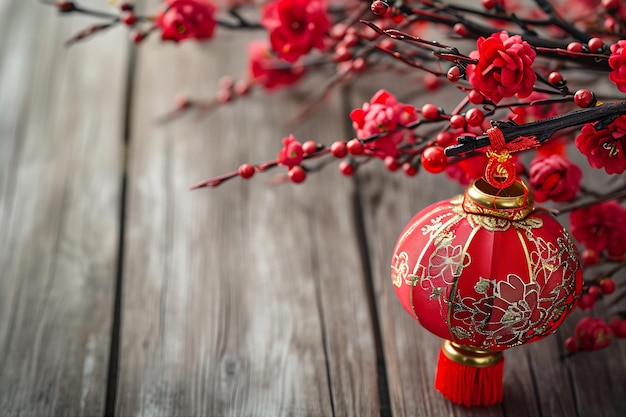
[0,0,626,417]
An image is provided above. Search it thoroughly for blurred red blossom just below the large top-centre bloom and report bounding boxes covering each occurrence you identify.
[248,41,304,90]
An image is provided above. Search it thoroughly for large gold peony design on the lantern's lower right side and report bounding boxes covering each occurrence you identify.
[449,224,579,349]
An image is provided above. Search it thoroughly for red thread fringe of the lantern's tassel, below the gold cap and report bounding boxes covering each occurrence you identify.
[435,348,504,407]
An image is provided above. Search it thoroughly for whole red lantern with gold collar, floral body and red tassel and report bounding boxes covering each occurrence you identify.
[391,179,582,406]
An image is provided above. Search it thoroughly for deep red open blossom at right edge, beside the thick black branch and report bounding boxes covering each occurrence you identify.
[576,115,626,174]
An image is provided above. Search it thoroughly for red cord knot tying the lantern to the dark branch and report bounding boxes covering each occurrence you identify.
[484,127,539,190]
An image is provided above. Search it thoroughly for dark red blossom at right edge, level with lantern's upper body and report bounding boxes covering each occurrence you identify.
[570,200,626,257]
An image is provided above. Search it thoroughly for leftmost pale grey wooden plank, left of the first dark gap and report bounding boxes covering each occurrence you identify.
[0,0,126,416]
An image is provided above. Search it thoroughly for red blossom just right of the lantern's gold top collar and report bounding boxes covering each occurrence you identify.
[529,155,583,202]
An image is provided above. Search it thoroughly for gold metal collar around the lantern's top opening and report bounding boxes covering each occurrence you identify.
[463,178,535,221]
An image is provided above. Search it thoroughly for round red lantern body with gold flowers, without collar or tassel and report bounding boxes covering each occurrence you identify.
[392,180,582,351]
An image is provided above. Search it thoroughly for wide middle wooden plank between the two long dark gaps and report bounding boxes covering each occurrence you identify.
[116,23,380,417]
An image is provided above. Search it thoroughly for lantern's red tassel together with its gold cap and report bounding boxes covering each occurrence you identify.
[435,341,504,407]
